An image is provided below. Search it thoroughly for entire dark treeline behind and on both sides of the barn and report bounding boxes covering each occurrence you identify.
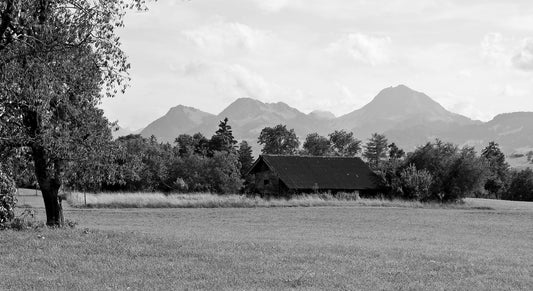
[4,118,533,202]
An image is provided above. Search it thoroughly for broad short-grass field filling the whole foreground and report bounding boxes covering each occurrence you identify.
[0,197,533,290]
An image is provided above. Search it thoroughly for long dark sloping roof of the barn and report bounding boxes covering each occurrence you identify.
[250,155,378,190]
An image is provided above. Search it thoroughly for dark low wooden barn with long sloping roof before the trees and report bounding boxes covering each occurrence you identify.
[248,155,379,196]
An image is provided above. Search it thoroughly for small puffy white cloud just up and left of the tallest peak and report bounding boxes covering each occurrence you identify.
[327,33,391,66]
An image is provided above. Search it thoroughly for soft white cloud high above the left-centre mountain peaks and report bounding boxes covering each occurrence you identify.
[183,22,270,55]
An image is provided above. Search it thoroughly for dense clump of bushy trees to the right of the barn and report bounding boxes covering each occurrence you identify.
[377,140,533,202]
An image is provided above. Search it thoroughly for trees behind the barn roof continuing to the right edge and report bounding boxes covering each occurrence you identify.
[258,125,533,202]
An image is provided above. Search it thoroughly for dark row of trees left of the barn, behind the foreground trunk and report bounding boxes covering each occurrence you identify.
[2,119,253,193]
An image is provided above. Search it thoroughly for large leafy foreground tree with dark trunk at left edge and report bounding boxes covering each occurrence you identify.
[0,0,144,226]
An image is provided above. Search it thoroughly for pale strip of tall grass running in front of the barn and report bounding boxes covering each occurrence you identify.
[67,192,476,208]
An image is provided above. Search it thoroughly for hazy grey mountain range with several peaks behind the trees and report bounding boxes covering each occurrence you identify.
[120,85,533,154]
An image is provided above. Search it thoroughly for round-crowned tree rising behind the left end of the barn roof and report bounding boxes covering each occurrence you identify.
[258,124,300,155]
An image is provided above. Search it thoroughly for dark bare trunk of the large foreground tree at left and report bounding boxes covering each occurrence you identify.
[32,146,63,227]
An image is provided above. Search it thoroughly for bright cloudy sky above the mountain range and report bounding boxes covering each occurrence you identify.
[101,0,533,129]
